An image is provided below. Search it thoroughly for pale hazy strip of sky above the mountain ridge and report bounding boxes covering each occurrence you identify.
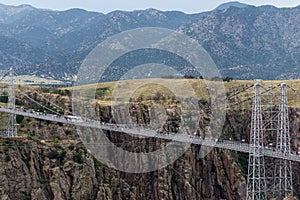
[0,0,300,13]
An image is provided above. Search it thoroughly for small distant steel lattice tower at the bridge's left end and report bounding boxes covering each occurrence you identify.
[6,68,17,137]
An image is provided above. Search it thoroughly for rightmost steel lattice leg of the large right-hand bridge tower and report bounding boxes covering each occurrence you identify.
[273,83,293,199]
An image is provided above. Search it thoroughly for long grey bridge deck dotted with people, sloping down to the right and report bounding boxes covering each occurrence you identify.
[0,107,300,162]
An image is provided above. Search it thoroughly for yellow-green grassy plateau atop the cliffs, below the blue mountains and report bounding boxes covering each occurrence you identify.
[67,79,300,107]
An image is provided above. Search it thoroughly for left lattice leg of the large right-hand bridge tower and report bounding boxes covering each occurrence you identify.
[247,84,267,200]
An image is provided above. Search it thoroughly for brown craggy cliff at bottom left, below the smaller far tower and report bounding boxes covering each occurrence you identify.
[0,138,98,200]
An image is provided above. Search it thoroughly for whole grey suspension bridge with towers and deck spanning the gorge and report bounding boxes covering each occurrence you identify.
[0,69,300,200]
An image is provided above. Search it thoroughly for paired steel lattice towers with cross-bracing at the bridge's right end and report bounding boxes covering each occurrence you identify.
[247,83,293,200]
